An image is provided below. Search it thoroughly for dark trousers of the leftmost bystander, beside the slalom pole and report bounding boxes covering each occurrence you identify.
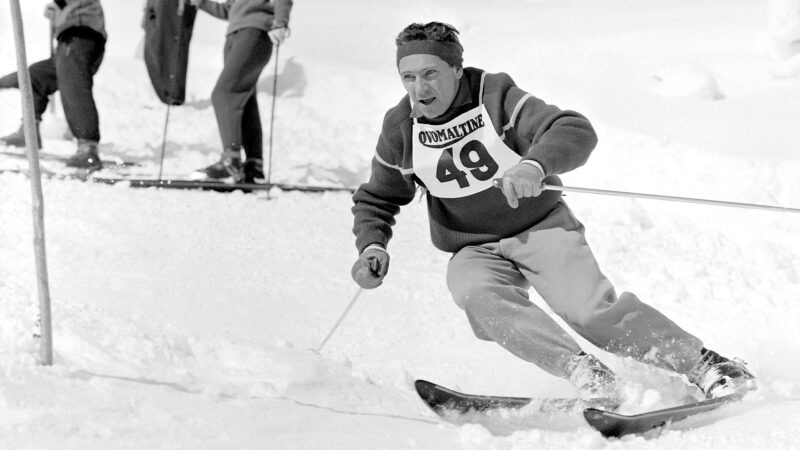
[0,36,105,142]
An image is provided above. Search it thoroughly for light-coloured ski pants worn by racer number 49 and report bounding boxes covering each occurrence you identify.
[447,202,703,378]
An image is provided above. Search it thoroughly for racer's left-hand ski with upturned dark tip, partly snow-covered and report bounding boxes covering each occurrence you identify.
[414,380,619,417]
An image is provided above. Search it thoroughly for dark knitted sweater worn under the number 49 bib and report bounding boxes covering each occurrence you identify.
[352,68,597,253]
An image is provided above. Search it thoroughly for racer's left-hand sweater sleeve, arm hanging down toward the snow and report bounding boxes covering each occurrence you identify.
[352,114,416,253]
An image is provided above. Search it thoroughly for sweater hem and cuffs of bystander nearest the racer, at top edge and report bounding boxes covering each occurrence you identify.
[197,0,292,35]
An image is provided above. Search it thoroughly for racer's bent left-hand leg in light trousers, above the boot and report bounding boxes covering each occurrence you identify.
[447,244,581,378]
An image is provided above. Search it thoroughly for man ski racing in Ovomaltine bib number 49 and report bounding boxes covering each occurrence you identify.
[352,22,755,397]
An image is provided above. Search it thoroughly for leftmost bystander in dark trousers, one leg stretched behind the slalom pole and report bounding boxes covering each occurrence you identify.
[0,0,108,170]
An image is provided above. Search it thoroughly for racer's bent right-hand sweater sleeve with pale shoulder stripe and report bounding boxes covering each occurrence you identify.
[490,74,597,175]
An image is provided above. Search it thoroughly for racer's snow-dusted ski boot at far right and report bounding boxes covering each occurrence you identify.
[688,348,756,398]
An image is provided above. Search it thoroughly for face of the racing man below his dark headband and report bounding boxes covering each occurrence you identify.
[397,54,464,119]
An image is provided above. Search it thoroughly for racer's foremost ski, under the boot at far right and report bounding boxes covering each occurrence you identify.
[583,392,744,437]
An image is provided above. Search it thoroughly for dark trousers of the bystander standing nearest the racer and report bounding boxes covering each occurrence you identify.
[211,28,272,158]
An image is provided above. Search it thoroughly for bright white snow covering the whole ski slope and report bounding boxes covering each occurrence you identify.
[0,0,800,450]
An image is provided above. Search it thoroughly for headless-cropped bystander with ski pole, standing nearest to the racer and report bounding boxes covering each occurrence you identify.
[191,0,292,183]
